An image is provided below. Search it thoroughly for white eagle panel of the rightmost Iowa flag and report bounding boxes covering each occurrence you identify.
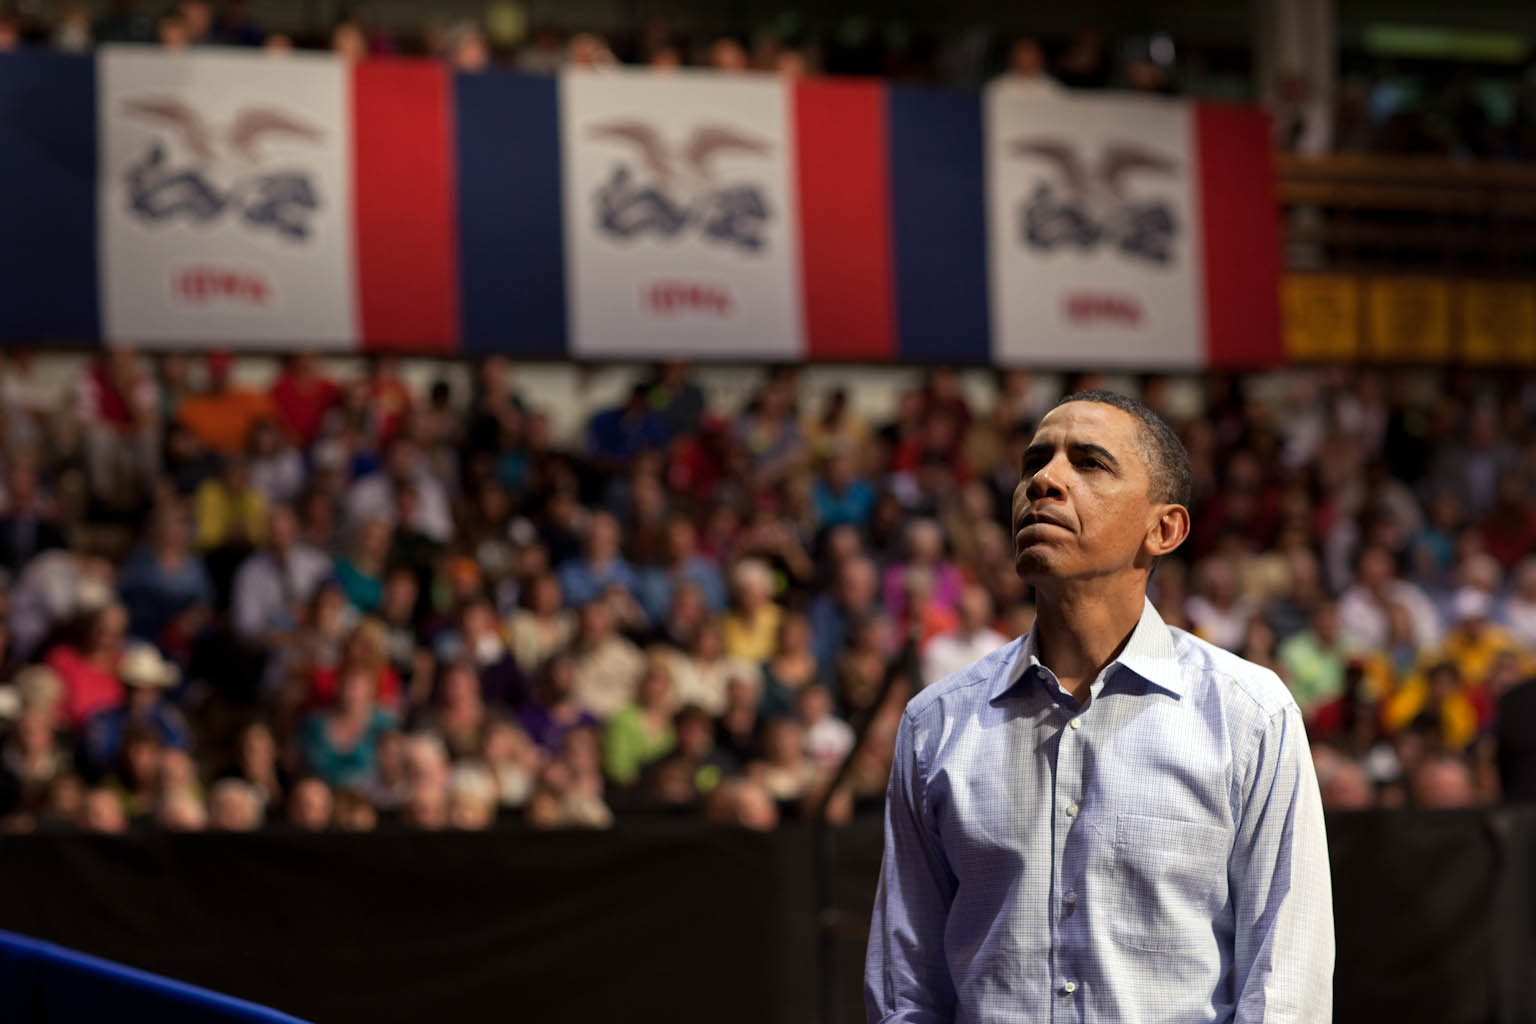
[983,83,1206,367]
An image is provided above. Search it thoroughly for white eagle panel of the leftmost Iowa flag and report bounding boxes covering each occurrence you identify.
[97,46,358,348]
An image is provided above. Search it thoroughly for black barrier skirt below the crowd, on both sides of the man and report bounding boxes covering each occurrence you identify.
[0,809,1536,1024]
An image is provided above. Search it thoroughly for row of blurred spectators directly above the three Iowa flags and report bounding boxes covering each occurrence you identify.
[0,0,1174,91]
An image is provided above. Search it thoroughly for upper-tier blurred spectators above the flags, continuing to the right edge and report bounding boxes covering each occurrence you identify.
[12,0,1536,160]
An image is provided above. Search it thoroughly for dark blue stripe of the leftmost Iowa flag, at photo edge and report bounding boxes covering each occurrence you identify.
[0,52,101,342]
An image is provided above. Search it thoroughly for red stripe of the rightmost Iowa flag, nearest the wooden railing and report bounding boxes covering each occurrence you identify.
[1195,104,1284,367]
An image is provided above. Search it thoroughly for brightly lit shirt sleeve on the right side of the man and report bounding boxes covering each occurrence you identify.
[1229,705,1333,1024]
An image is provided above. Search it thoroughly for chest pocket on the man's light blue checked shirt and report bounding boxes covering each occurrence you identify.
[1112,814,1232,953]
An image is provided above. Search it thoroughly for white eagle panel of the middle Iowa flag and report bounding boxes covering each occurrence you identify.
[559,69,805,359]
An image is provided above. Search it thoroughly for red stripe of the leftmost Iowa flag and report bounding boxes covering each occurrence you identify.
[352,60,458,350]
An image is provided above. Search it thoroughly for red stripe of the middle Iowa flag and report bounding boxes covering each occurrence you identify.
[794,80,895,359]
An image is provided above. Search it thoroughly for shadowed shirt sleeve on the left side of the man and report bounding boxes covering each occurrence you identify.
[865,715,955,1024]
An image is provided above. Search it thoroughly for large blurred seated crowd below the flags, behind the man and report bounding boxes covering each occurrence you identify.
[0,350,1536,831]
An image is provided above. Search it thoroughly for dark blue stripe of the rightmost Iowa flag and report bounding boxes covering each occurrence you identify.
[889,86,991,362]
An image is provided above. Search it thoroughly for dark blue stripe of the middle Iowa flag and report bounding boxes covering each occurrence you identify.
[455,72,565,355]
